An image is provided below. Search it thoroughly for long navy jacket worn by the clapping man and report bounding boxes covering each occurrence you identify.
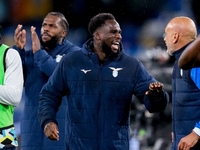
[14,40,80,150]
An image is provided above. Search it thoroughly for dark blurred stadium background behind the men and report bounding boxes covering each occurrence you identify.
[0,0,200,150]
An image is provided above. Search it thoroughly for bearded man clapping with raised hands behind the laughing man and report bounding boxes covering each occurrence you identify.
[14,12,79,150]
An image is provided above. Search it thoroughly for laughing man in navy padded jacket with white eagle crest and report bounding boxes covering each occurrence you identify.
[39,13,168,150]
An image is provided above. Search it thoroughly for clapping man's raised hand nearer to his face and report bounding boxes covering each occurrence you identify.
[31,26,40,53]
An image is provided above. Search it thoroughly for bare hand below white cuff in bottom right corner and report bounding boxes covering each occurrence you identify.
[178,131,200,150]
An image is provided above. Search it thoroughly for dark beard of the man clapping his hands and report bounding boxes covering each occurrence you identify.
[40,36,58,51]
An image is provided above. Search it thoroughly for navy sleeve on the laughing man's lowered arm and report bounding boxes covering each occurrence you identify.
[38,59,66,129]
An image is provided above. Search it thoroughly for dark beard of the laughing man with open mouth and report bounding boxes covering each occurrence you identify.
[102,42,121,59]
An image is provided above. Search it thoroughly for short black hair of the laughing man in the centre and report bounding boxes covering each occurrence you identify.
[88,13,115,35]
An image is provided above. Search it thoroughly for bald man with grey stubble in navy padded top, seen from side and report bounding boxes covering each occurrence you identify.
[164,17,200,150]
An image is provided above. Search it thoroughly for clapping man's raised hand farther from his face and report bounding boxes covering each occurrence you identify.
[14,24,26,49]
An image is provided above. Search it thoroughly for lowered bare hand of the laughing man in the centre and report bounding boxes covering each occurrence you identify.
[44,122,59,141]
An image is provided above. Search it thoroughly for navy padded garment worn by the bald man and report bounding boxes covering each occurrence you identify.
[172,45,200,150]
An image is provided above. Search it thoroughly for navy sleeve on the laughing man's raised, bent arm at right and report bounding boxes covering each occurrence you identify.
[134,62,169,112]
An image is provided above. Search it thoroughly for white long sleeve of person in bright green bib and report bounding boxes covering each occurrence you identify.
[0,48,24,106]
